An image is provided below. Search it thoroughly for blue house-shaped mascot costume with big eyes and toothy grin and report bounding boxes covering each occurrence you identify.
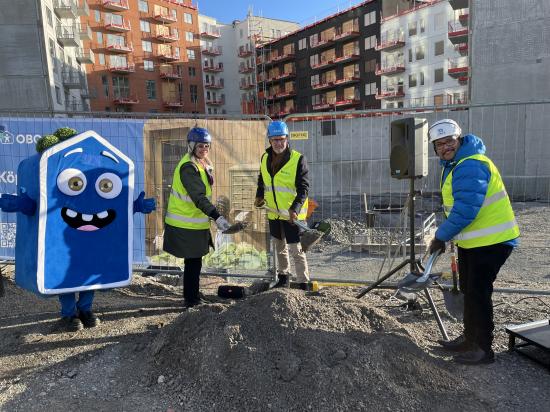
[0,128,155,331]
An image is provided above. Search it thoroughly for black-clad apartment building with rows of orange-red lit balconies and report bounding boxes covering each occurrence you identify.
[257,0,381,117]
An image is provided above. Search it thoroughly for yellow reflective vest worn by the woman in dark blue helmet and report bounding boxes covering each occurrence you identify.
[164,154,212,230]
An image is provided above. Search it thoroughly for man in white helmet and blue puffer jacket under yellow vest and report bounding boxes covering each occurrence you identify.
[428,119,519,365]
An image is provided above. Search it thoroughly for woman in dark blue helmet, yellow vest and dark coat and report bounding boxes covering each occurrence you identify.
[163,127,230,307]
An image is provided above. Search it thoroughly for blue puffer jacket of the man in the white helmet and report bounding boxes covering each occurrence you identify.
[435,134,518,247]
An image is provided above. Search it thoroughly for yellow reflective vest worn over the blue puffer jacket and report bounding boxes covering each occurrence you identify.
[441,154,519,249]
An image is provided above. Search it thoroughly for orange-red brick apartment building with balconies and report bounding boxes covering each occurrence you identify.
[81,0,204,113]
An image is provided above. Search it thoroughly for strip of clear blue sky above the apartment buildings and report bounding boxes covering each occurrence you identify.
[197,0,362,25]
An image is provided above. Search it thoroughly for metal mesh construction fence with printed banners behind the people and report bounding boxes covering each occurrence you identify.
[0,102,550,282]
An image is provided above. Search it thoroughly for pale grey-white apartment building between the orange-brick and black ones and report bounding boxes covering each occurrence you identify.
[199,12,300,114]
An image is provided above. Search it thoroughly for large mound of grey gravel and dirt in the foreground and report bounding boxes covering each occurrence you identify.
[148,289,483,411]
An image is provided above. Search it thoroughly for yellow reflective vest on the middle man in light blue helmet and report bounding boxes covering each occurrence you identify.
[260,150,308,220]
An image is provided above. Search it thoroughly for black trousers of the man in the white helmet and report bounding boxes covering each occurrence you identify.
[458,243,513,352]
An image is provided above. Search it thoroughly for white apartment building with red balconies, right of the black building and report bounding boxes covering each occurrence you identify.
[376,0,470,108]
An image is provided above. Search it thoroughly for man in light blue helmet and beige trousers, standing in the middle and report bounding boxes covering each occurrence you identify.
[254,121,310,290]
